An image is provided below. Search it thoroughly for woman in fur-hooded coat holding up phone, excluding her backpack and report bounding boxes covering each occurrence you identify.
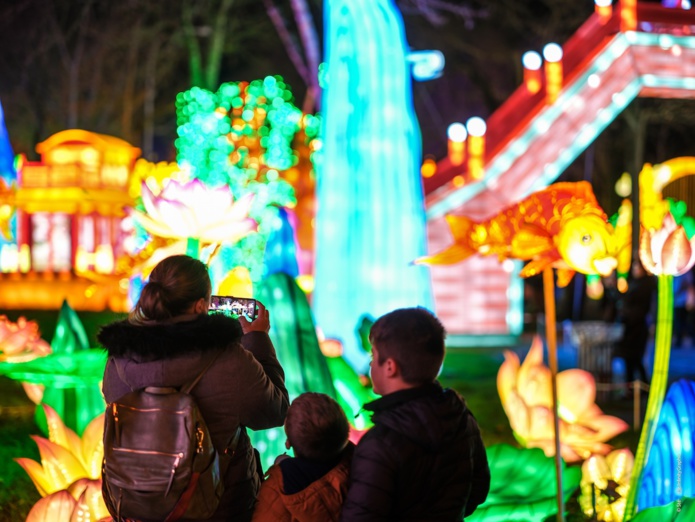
[98,255,289,521]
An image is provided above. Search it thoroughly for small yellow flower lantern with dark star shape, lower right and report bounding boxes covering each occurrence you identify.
[579,448,634,522]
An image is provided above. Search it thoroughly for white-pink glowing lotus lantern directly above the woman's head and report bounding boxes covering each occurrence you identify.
[133,179,256,257]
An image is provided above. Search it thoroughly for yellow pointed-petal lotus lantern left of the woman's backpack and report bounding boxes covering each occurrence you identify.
[15,404,104,497]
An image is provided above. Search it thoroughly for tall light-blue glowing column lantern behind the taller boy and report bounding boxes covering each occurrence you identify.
[313,0,433,370]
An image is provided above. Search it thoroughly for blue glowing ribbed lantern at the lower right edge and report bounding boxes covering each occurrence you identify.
[637,379,695,511]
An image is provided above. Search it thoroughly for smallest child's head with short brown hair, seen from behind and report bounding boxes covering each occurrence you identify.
[285,392,350,460]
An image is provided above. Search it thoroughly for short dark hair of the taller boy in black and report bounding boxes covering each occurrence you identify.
[369,308,446,384]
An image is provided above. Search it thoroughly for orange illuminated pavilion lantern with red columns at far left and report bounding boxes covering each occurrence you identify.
[0,129,140,310]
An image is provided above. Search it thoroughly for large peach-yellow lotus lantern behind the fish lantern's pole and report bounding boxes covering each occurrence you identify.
[497,337,628,462]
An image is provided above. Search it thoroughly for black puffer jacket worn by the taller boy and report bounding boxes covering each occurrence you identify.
[341,382,490,522]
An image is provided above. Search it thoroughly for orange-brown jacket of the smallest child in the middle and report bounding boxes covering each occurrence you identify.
[253,442,353,522]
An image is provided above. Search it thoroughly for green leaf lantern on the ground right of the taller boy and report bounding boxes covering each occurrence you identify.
[466,444,582,522]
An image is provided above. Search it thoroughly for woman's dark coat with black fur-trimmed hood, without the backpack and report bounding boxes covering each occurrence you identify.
[98,315,289,522]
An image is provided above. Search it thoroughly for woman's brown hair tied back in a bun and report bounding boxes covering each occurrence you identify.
[129,255,211,323]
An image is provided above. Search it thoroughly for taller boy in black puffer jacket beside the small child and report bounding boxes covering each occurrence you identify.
[341,308,490,522]
